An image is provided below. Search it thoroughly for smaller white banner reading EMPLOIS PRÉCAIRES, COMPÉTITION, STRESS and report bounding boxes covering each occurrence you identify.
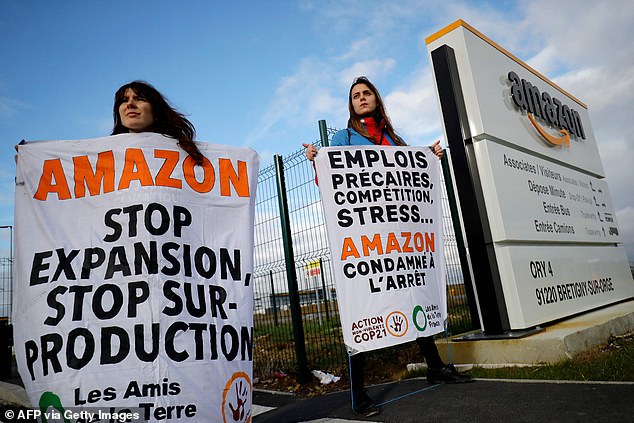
[315,146,447,354]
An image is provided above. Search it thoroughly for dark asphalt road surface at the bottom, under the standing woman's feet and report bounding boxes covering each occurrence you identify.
[253,379,634,423]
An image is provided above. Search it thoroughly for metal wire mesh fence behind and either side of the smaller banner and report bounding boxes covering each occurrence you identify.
[253,128,473,378]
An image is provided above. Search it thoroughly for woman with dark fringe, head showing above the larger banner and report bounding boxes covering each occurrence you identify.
[110,81,203,165]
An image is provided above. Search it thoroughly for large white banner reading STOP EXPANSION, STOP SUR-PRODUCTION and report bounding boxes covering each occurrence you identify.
[13,133,259,422]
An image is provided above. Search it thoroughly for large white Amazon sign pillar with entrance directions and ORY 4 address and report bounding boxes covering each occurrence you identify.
[426,20,634,335]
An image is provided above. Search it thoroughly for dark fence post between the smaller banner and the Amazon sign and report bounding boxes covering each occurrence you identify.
[440,151,480,329]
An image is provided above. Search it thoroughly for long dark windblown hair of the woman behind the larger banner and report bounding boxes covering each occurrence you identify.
[111,81,204,165]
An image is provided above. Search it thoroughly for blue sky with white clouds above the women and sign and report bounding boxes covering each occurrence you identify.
[0,0,634,262]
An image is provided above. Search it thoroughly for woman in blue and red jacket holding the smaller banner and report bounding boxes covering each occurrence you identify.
[303,77,472,417]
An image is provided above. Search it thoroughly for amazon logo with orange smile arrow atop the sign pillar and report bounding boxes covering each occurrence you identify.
[508,71,586,147]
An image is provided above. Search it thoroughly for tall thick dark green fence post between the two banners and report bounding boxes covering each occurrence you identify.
[273,154,309,384]
